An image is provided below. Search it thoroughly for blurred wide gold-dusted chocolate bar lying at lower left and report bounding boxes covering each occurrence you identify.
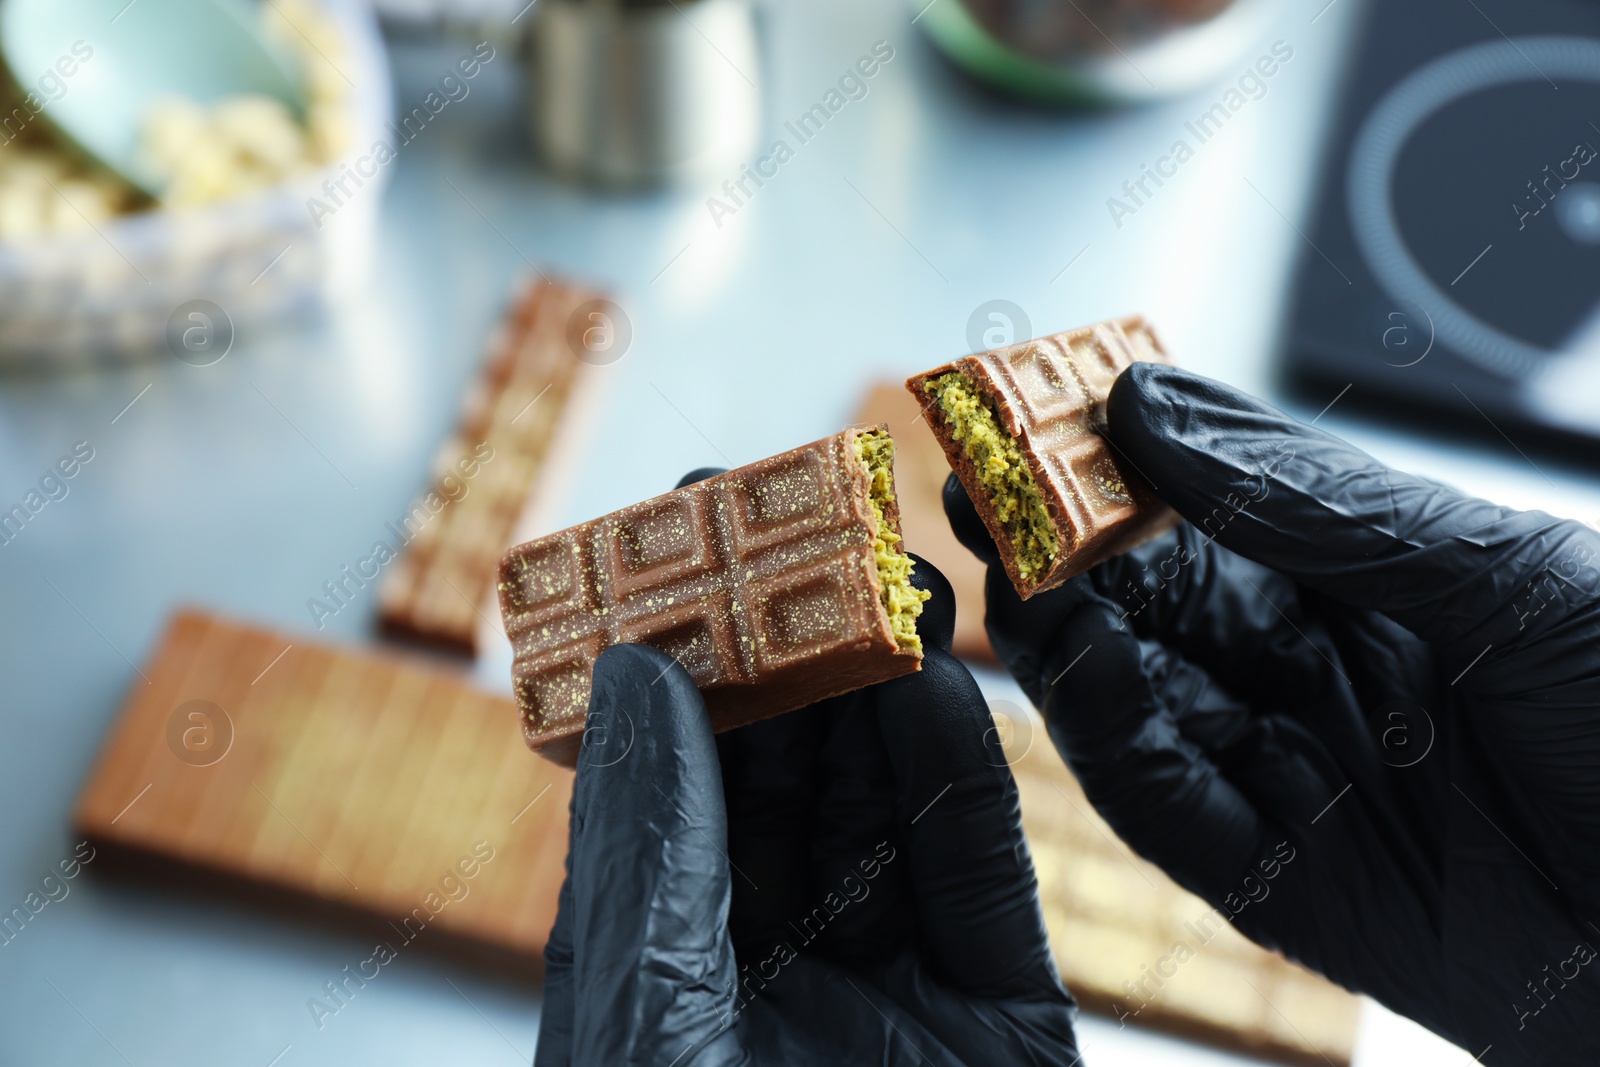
[74,611,571,958]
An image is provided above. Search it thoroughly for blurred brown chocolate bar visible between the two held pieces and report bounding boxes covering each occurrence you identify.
[856,378,995,662]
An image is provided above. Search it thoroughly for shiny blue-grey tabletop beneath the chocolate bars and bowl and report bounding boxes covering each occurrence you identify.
[0,0,1600,1067]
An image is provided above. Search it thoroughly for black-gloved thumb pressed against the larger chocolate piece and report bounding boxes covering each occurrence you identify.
[563,645,736,1064]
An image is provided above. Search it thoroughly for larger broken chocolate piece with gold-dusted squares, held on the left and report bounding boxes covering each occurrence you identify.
[499,426,928,766]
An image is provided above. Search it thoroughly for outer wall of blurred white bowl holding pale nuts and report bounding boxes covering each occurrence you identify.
[0,0,394,371]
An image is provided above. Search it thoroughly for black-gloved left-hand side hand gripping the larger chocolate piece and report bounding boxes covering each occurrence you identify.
[534,472,1077,1067]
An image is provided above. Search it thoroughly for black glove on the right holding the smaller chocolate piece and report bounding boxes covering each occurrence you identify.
[946,363,1600,1064]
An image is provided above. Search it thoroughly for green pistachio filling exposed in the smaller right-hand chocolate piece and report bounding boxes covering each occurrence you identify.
[923,371,1061,581]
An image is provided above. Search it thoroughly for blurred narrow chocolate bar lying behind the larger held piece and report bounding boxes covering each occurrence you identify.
[378,277,605,656]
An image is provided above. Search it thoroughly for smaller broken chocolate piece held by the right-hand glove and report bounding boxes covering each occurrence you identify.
[906,317,1176,600]
